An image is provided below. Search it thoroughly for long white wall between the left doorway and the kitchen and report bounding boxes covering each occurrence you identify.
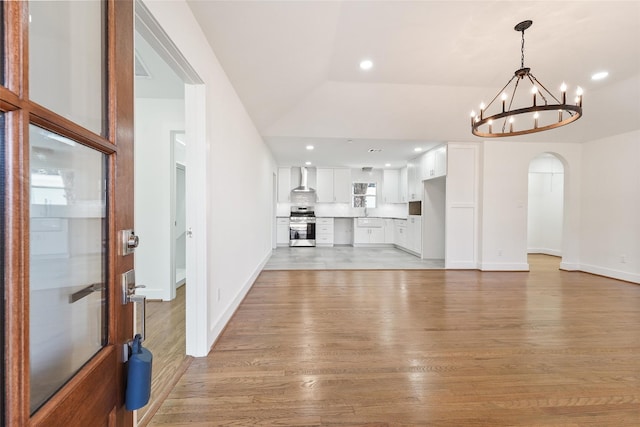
[144,0,276,355]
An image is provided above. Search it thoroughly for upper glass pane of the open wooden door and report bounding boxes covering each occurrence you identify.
[29,0,107,135]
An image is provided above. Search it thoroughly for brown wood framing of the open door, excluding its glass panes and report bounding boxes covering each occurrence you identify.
[0,0,133,426]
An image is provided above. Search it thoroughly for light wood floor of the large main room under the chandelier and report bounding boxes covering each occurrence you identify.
[150,256,640,427]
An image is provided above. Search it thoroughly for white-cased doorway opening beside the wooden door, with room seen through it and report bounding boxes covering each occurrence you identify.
[134,1,206,425]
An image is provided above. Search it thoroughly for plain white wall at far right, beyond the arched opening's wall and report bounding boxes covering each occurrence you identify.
[580,131,640,283]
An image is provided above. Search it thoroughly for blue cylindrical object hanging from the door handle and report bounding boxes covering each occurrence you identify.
[125,334,153,411]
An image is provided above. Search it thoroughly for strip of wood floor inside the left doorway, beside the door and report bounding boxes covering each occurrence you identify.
[138,286,191,426]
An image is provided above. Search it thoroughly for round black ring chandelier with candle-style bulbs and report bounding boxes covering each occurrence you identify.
[471,21,582,138]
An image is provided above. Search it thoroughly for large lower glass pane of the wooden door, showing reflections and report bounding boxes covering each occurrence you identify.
[29,125,107,413]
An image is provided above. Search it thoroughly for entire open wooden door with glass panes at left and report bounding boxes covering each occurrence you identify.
[0,0,134,426]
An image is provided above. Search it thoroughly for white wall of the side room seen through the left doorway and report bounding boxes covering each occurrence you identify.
[134,98,184,301]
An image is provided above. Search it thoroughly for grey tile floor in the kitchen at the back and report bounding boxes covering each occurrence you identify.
[264,246,444,270]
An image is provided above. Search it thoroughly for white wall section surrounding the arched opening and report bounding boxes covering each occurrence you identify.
[480,141,582,270]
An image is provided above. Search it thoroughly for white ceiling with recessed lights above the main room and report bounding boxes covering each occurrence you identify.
[182,0,640,167]
